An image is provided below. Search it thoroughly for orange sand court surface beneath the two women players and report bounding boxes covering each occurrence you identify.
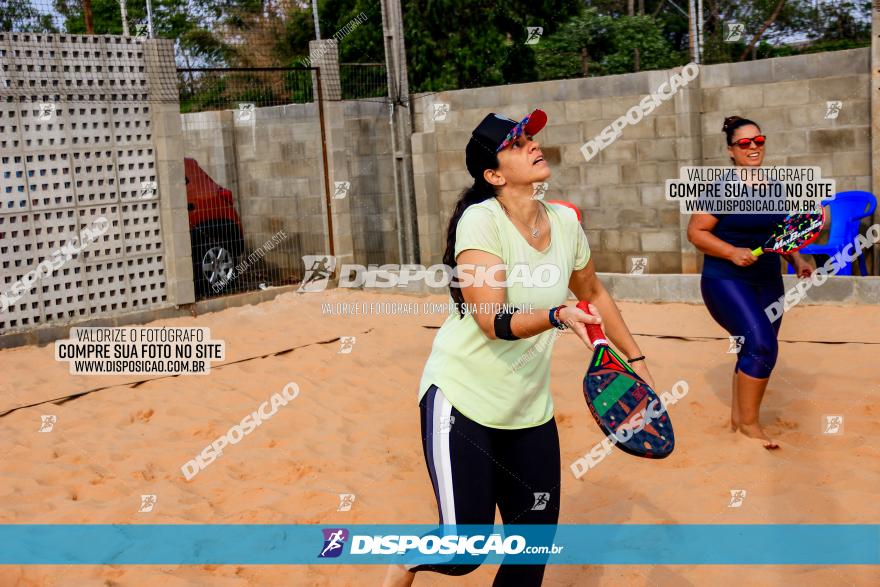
[0,290,880,586]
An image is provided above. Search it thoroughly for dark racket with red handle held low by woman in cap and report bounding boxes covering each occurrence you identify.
[577,301,675,459]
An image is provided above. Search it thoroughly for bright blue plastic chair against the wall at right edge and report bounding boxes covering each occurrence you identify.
[788,191,877,275]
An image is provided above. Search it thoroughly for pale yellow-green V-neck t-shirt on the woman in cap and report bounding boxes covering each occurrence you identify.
[419,198,590,429]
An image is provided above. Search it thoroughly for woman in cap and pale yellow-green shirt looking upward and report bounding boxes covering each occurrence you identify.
[385,110,653,587]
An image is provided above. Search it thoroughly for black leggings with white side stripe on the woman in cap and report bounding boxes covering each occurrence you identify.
[410,385,560,587]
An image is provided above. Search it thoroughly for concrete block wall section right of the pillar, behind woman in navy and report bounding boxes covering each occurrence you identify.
[696,49,872,269]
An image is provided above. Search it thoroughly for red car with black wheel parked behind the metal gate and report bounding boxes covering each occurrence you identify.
[183,157,244,297]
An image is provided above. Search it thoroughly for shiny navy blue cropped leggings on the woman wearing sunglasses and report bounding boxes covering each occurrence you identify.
[700,276,784,379]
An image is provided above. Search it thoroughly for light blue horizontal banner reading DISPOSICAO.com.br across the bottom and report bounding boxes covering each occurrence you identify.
[0,524,880,565]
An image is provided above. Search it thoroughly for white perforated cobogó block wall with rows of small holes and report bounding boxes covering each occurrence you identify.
[0,33,167,334]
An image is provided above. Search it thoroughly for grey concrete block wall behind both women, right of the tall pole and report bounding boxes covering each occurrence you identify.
[412,49,871,273]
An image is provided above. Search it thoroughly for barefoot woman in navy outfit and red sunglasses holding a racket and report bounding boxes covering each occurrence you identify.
[688,116,813,449]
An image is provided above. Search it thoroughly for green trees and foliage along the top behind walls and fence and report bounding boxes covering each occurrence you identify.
[0,0,871,101]
